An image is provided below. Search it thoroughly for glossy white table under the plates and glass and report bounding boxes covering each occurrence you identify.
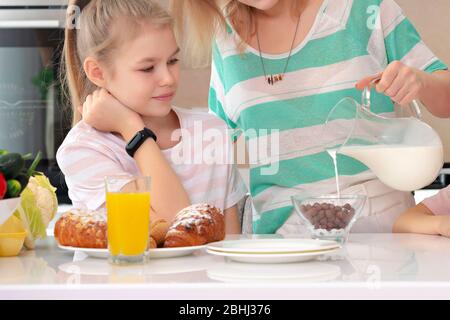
[0,234,450,300]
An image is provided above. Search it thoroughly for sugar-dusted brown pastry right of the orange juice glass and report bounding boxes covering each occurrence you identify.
[164,204,225,248]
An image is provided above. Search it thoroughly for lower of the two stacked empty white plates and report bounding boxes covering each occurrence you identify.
[206,247,340,263]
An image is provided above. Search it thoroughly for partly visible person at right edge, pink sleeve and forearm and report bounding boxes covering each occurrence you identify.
[393,186,450,237]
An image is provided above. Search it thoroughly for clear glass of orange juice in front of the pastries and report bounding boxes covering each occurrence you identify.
[105,175,151,265]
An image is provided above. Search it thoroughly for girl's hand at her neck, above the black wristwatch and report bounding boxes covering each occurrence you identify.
[78,88,144,140]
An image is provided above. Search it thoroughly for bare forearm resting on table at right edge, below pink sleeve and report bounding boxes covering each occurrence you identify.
[393,203,450,237]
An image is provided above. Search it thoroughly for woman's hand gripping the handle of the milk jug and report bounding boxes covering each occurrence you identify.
[356,61,425,105]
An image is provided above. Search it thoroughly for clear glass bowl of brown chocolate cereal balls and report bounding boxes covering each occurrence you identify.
[291,195,367,244]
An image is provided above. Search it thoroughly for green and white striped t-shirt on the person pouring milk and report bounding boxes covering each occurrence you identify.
[209,0,447,233]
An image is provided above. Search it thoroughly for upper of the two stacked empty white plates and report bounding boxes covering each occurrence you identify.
[207,238,340,254]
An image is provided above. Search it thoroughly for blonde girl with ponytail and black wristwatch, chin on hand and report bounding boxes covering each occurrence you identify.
[57,0,245,233]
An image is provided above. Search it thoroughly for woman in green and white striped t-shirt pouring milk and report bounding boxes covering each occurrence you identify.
[172,0,450,234]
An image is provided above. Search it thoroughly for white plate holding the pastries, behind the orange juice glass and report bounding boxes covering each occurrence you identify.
[58,245,206,259]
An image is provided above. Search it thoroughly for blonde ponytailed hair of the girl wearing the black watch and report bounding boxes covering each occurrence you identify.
[61,0,172,125]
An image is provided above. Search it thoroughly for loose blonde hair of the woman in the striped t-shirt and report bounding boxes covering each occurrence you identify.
[170,0,300,67]
